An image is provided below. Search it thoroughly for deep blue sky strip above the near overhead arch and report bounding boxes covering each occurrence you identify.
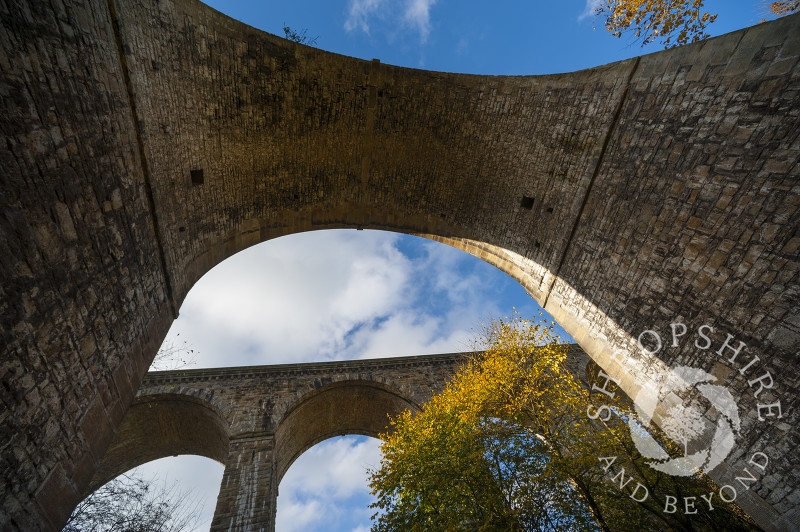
[200,0,766,75]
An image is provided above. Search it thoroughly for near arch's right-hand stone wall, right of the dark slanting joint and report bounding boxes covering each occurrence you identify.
[547,17,800,530]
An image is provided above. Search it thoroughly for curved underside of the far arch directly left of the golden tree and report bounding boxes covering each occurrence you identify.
[275,380,419,483]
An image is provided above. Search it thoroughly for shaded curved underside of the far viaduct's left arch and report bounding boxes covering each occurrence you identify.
[84,393,230,496]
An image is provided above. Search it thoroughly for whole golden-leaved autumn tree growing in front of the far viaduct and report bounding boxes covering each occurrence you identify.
[370,318,754,532]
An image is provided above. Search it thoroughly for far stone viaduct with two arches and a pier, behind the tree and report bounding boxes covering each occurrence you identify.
[89,353,468,531]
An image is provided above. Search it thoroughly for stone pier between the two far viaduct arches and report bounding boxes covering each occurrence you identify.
[211,432,278,532]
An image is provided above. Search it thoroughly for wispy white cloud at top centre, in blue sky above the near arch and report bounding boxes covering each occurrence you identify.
[344,0,436,43]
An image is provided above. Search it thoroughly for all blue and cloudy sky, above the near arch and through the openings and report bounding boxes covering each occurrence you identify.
[123,0,765,532]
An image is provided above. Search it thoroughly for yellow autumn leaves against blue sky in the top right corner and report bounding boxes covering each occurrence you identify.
[594,0,800,48]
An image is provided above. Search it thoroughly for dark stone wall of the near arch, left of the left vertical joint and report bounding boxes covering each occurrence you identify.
[0,1,173,530]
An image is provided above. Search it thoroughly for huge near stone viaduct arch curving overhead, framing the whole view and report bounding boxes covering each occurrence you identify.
[0,0,800,530]
